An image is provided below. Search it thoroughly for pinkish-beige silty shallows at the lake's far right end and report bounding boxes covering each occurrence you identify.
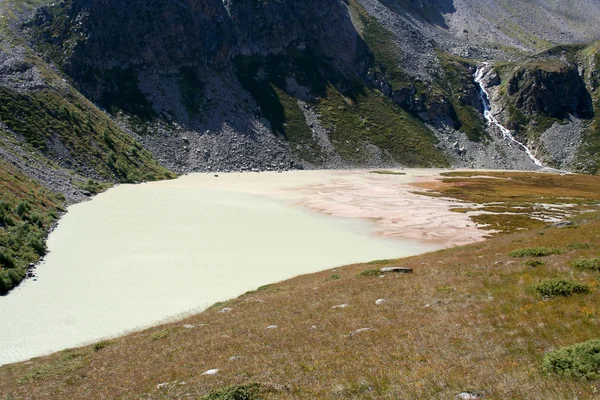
[172,169,489,247]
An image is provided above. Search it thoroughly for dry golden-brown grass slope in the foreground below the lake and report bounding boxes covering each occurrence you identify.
[0,173,600,399]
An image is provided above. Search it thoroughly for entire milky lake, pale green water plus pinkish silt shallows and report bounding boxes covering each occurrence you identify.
[0,170,478,364]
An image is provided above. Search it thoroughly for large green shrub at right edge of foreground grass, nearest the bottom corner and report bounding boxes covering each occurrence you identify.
[542,339,600,380]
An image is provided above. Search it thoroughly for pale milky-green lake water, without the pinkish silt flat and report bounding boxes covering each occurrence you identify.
[0,173,439,364]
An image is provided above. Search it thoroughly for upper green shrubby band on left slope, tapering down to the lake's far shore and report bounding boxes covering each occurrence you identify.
[0,88,174,182]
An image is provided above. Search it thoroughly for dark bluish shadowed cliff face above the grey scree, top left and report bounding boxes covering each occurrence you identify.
[35,0,356,73]
